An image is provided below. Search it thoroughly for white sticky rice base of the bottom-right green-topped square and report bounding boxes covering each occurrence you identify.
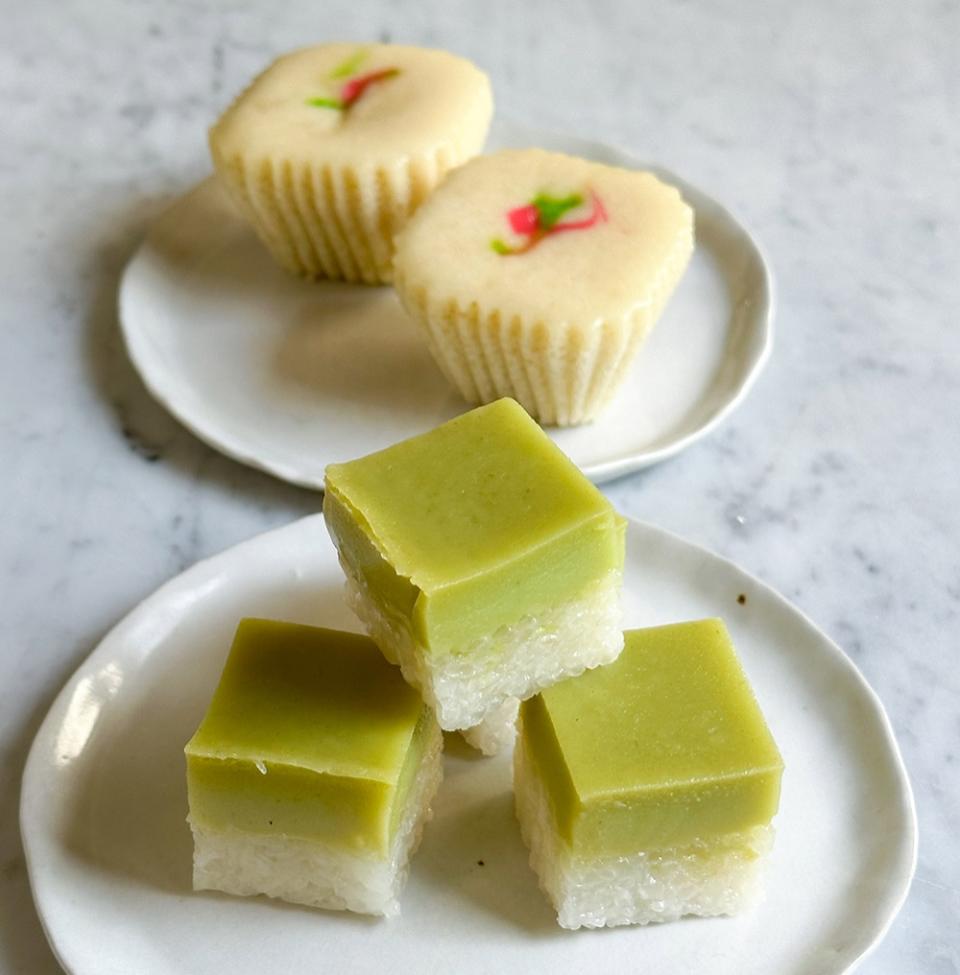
[514,735,773,929]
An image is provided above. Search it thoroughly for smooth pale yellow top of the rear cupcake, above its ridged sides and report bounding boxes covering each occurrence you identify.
[210,44,493,168]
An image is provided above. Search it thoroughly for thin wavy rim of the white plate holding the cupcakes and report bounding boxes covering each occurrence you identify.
[116,117,777,492]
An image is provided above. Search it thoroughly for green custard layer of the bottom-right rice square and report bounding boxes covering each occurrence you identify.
[521,619,783,856]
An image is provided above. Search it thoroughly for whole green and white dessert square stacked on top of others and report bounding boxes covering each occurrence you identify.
[323,399,624,730]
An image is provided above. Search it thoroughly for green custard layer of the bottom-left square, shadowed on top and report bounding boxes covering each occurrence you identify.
[185,619,435,855]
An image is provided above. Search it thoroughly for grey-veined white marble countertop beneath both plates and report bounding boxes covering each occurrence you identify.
[0,0,960,975]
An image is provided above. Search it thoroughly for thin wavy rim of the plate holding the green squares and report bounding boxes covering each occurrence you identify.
[18,513,919,975]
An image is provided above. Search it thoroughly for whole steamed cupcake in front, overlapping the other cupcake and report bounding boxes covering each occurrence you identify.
[394,149,693,426]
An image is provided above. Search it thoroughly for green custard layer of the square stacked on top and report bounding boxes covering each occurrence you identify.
[324,399,624,653]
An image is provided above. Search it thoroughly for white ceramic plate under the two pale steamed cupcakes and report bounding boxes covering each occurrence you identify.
[120,123,773,487]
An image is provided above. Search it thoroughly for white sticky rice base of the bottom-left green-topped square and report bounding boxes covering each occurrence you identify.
[190,725,443,917]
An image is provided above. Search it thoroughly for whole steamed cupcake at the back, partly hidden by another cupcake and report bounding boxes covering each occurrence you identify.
[210,44,493,284]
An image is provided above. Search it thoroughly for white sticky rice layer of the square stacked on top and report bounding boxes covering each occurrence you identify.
[340,560,623,731]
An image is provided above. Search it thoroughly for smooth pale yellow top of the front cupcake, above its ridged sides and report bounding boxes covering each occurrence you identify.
[394,149,693,325]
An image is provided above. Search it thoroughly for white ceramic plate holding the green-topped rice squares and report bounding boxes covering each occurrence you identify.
[21,516,916,975]
